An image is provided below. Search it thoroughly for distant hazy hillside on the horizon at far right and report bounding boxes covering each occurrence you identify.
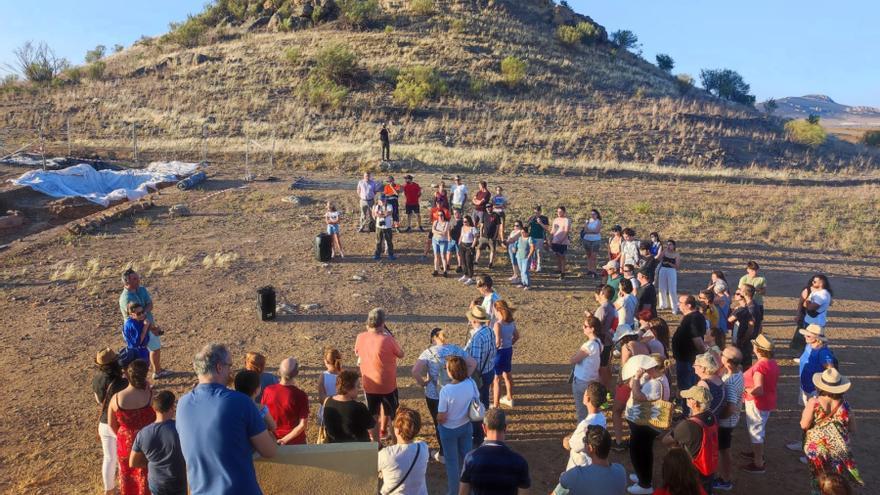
[757,95,880,127]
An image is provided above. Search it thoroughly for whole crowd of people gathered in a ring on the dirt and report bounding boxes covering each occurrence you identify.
[92,174,862,495]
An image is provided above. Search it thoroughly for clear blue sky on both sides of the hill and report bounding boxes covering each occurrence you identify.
[0,0,880,107]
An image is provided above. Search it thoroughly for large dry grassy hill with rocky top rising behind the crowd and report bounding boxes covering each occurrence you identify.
[0,0,878,174]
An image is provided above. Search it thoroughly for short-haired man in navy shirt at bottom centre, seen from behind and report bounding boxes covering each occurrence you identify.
[458,408,532,495]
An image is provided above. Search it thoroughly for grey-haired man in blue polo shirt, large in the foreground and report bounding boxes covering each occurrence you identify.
[177,344,277,495]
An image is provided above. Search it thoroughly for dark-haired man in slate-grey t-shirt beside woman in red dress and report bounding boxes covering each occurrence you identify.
[128,390,186,495]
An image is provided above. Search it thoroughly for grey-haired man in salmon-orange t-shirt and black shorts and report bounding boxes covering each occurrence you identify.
[354,308,403,438]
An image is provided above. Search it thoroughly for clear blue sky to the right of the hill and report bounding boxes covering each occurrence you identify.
[568,0,880,107]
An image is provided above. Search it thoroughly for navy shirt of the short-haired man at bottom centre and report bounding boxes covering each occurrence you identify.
[460,440,532,495]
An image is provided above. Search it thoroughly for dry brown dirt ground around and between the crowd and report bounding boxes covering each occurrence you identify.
[0,171,880,495]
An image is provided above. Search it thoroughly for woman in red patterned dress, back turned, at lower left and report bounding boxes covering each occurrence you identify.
[107,359,156,495]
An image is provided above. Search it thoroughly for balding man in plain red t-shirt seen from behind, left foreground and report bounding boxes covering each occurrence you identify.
[261,357,309,445]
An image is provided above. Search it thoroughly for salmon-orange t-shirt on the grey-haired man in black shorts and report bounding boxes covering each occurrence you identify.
[354,331,403,394]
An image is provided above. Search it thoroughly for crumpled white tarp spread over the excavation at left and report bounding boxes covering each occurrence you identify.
[12,162,199,206]
